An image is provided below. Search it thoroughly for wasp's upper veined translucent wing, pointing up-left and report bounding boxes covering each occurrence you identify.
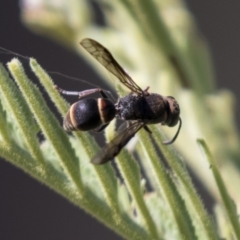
[80,38,143,94]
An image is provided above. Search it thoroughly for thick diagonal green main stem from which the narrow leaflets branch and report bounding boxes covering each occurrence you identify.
[0,142,148,240]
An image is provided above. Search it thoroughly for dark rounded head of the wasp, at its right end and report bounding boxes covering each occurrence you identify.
[165,96,180,127]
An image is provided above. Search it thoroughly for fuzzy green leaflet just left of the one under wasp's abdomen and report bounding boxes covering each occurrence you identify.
[8,59,84,195]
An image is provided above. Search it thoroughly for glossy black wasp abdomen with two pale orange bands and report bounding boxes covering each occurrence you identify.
[63,98,115,131]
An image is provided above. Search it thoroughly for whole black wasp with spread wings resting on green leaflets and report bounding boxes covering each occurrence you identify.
[58,38,182,164]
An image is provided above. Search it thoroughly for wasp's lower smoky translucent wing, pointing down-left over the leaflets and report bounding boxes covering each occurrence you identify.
[91,122,145,164]
